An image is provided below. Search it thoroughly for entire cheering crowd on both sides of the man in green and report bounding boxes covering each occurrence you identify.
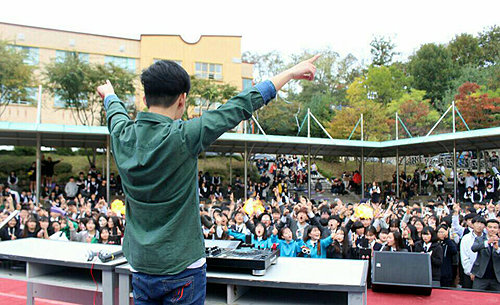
[0,156,500,291]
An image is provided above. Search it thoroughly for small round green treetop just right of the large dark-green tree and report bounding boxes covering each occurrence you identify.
[448,33,483,67]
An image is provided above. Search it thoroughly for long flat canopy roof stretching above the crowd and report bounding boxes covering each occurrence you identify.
[0,122,500,157]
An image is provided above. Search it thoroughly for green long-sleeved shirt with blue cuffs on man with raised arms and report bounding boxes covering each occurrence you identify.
[104,81,276,275]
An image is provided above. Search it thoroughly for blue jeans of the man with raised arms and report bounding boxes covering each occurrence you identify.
[132,264,207,305]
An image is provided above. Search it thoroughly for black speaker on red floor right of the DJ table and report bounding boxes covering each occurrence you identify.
[372,251,432,295]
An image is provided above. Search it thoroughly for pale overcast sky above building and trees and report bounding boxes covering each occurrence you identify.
[0,0,500,60]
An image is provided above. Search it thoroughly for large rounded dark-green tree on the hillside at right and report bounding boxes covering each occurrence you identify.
[409,43,457,103]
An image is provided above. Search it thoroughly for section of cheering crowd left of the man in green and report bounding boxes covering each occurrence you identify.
[0,157,125,245]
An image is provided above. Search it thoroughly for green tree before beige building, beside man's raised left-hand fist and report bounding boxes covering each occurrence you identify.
[44,53,136,126]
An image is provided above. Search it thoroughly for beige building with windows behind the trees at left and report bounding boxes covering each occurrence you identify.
[0,22,253,125]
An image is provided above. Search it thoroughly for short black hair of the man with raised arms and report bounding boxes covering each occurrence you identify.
[141,60,191,108]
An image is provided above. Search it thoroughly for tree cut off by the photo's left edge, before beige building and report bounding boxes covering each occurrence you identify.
[0,40,33,117]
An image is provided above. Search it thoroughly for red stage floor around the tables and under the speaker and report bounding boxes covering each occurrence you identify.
[0,279,500,305]
